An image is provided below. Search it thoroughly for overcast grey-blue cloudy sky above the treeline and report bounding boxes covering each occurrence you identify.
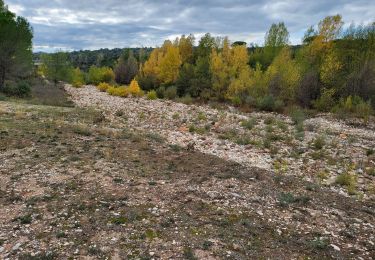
[5,0,375,51]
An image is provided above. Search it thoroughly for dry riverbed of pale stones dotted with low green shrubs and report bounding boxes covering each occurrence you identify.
[66,85,375,199]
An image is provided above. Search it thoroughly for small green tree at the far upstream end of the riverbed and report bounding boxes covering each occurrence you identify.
[41,52,72,84]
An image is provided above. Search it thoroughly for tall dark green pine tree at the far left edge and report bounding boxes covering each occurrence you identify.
[0,0,33,90]
